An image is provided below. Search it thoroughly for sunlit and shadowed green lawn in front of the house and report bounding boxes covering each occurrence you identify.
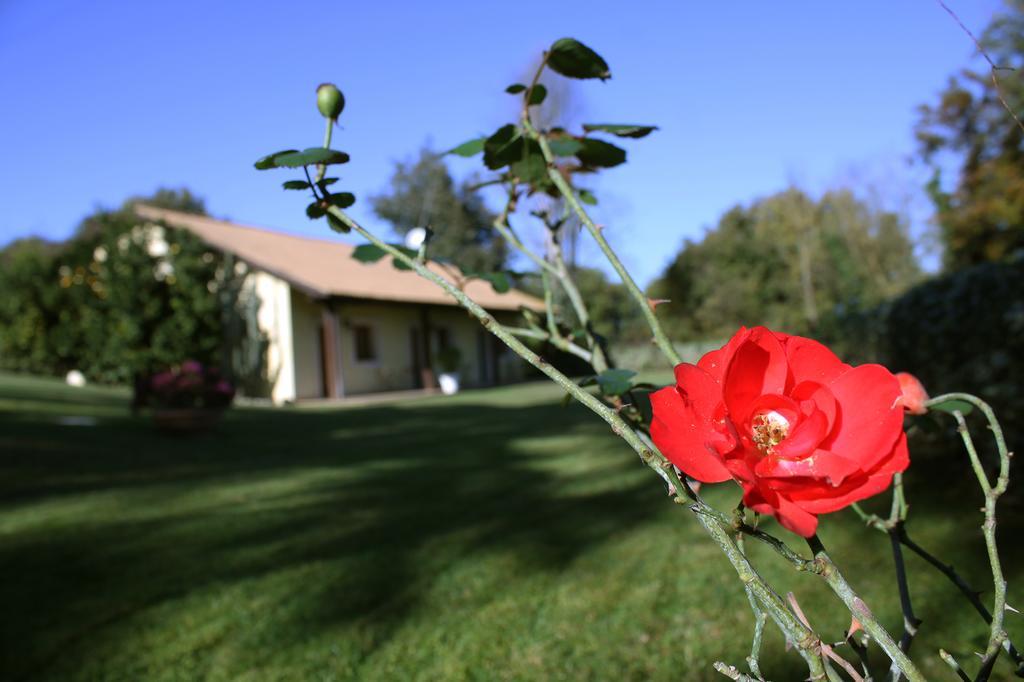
[0,375,1024,682]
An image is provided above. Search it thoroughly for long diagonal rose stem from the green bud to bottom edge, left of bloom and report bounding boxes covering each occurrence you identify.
[328,206,827,680]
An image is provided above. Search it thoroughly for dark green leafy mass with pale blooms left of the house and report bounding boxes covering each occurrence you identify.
[0,189,263,393]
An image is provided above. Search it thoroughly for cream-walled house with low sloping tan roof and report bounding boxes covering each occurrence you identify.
[135,205,543,403]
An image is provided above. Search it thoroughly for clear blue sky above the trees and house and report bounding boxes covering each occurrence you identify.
[0,0,1001,282]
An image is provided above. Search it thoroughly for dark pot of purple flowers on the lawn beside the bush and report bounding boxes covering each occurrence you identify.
[148,360,234,432]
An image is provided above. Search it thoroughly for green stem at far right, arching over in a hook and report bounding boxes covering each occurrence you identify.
[925,393,1011,682]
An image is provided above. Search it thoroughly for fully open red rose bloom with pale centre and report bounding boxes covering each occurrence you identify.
[650,327,909,538]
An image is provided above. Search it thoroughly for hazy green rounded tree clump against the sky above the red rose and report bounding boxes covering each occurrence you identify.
[650,189,921,338]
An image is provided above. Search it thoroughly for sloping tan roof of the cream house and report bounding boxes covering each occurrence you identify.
[134,204,544,310]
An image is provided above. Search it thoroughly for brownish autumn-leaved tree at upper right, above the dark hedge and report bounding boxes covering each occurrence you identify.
[915,0,1024,269]
